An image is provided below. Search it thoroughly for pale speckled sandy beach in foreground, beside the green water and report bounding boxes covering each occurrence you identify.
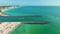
[0,22,21,34]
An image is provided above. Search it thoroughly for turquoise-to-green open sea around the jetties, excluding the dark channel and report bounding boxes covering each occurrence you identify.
[4,6,60,34]
